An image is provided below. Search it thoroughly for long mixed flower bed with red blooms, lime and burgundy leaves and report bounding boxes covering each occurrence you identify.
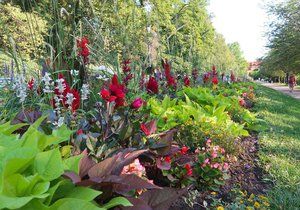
[0,59,267,209]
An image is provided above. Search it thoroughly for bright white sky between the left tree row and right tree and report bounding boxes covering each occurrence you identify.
[208,0,268,61]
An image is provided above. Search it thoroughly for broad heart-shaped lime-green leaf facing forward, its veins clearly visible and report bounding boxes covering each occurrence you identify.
[34,148,64,181]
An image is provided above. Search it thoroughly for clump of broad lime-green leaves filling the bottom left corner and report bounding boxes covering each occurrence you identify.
[0,117,131,210]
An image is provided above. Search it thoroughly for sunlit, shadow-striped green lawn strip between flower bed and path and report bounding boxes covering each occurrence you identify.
[254,86,300,210]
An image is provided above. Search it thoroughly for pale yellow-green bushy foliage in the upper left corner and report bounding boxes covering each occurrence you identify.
[0,4,47,60]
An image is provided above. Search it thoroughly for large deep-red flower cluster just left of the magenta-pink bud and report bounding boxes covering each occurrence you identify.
[100,74,126,108]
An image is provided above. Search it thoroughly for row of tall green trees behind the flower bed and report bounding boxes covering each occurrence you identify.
[0,0,246,73]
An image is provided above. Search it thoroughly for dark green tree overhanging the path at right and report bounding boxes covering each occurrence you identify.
[262,0,300,73]
